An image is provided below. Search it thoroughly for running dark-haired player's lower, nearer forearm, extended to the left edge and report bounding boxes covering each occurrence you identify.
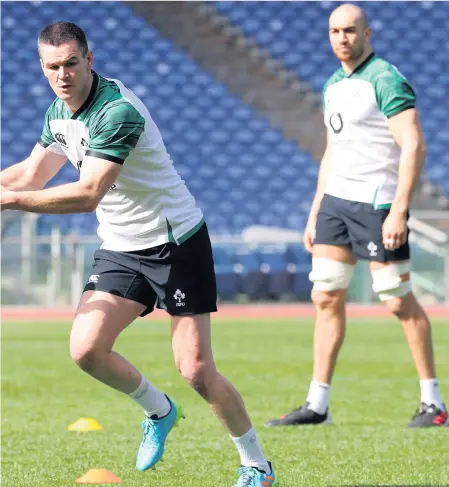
[3,182,98,214]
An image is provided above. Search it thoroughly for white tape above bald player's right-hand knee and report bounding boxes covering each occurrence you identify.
[371,260,412,301]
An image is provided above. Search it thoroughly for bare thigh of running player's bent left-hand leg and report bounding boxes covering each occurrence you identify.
[70,291,146,358]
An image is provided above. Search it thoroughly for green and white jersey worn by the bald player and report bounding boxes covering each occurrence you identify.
[323,53,416,208]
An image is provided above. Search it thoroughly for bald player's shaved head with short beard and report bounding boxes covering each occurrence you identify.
[329,3,372,71]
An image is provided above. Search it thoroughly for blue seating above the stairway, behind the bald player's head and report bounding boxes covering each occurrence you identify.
[215,1,449,194]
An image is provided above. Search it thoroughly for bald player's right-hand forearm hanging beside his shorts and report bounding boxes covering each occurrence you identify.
[391,142,426,214]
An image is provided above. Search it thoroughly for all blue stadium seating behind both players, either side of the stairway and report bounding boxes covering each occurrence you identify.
[1,1,449,299]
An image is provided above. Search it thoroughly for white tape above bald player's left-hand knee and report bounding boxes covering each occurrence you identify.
[309,257,354,291]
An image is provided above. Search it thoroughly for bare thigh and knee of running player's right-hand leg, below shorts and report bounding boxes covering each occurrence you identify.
[171,313,215,377]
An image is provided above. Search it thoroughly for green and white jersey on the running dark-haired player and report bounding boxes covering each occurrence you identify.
[40,73,203,251]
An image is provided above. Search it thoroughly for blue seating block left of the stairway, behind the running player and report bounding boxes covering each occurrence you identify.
[2,2,317,235]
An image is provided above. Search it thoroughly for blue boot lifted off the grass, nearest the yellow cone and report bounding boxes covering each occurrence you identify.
[136,396,185,472]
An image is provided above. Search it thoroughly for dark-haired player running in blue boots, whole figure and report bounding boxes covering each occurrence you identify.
[1,22,276,487]
